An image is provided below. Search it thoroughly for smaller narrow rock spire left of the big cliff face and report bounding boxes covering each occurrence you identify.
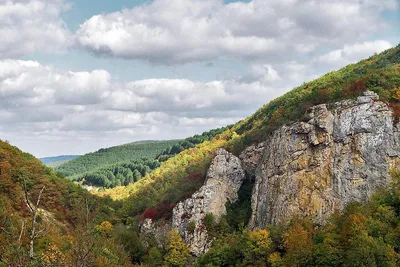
[172,149,245,255]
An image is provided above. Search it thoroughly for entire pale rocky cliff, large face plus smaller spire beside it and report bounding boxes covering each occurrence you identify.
[148,92,400,255]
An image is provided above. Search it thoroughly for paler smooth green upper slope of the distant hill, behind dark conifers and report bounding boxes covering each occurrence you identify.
[55,140,179,177]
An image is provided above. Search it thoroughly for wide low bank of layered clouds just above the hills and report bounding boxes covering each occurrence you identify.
[0,41,394,155]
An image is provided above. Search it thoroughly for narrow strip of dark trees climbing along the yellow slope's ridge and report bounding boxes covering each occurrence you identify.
[157,125,233,162]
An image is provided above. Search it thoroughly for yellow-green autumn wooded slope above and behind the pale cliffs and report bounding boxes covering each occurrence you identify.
[101,46,400,218]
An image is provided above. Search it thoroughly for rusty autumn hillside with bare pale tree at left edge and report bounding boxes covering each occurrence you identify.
[0,140,131,266]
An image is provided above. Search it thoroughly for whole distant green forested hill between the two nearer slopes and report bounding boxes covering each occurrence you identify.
[55,126,232,188]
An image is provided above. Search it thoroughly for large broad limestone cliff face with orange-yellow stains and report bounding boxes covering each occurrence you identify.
[248,92,400,227]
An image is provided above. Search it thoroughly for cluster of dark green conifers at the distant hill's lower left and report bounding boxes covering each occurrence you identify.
[74,158,160,188]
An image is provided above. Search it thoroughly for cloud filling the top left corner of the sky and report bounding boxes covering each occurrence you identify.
[0,0,72,59]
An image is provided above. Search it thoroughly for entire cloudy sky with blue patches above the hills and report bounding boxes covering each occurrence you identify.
[0,0,400,157]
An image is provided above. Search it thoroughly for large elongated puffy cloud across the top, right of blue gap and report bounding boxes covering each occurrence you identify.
[76,0,398,64]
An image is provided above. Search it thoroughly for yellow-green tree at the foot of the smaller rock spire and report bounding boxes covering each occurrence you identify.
[164,229,190,267]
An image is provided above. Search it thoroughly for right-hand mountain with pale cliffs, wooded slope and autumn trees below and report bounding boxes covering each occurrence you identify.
[94,46,400,266]
